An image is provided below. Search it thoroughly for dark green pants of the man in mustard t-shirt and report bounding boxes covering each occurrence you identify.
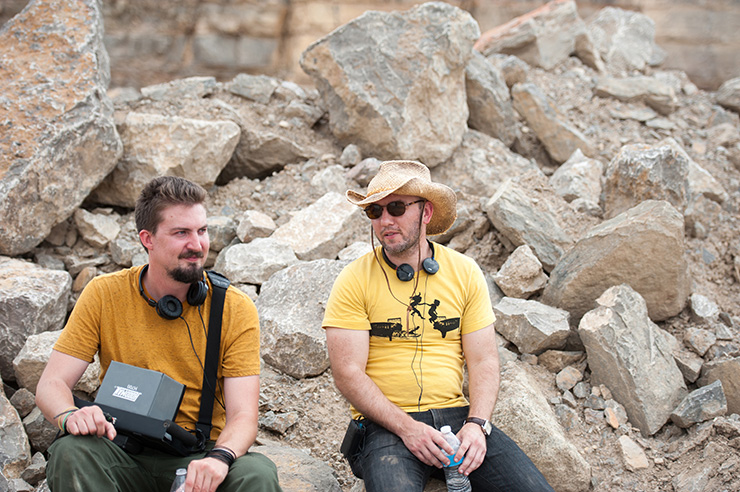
[46,436,281,492]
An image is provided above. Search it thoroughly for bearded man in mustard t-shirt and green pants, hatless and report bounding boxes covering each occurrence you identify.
[36,176,280,492]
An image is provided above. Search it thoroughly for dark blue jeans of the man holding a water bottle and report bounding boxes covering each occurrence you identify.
[351,407,554,492]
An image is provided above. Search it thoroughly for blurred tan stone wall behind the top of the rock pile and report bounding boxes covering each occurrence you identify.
[0,0,740,90]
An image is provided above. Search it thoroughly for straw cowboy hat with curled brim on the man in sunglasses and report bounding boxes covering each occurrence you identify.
[347,161,457,236]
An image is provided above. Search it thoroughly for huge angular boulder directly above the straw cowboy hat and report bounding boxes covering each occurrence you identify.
[300,2,480,166]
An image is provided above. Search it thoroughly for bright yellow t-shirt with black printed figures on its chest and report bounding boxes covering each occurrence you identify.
[322,244,496,418]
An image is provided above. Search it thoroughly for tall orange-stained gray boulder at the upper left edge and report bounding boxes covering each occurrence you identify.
[0,0,122,256]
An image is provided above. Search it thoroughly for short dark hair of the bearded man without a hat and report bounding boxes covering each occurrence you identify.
[134,176,208,234]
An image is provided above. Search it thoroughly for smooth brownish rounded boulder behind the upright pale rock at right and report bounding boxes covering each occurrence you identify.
[542,200,690,322]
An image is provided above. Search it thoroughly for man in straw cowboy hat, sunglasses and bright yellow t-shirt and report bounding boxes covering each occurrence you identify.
[322,161,552,492]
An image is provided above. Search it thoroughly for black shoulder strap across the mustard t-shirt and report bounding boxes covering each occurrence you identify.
[195,271,230,441]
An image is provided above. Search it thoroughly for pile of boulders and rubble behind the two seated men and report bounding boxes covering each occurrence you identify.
[0,0,740,492]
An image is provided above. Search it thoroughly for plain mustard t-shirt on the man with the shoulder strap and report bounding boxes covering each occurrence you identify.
[54,267,260,440]
